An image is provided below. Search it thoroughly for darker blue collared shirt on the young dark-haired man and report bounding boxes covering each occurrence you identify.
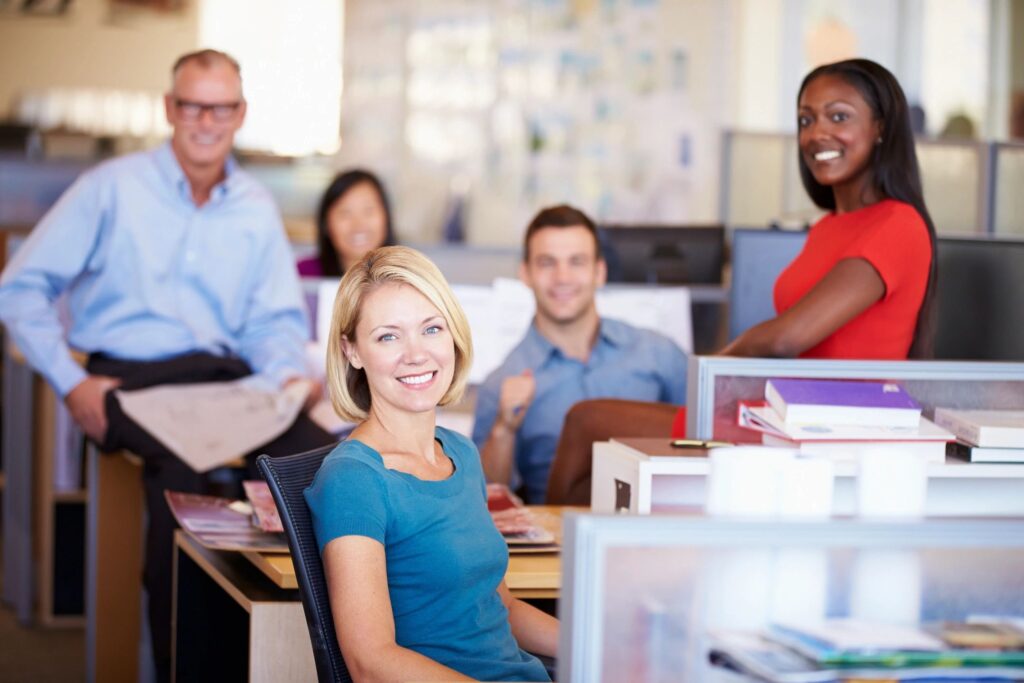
[473,318,686,503]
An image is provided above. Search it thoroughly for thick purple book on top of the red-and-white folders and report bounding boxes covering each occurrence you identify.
[765,379,921,427]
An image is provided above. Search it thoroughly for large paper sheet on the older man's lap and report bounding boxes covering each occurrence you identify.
[118,376,309,472]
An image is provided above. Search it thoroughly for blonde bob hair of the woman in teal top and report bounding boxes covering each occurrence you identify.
[327,247,473,422]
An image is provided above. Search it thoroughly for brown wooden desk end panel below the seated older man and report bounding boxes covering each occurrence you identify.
[85,444,145,683]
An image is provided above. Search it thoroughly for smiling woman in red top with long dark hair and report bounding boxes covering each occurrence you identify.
[721,59,935,359]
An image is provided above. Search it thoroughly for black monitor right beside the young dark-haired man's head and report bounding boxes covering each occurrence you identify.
[598,225,725,285]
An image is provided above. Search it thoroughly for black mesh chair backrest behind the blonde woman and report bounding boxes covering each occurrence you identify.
[256,445,352,683]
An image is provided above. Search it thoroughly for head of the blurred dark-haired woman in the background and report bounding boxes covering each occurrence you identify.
[298,169,395,278]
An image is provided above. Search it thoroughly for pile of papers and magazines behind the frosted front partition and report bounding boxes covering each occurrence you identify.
[709,618,1024,683]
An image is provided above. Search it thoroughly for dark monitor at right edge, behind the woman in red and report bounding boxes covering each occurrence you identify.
[935,238,1024,360]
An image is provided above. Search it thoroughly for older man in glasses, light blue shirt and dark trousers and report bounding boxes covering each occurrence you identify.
[0,50,334,680]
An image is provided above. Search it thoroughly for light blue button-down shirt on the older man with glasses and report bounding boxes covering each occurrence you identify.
[0,143,308,396]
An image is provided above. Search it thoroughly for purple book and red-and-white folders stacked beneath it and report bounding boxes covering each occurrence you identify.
[738,379,955,463]
